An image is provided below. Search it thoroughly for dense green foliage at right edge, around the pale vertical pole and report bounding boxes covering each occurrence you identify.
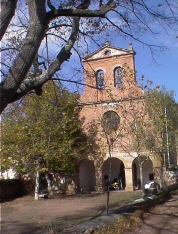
[146,88,178,157]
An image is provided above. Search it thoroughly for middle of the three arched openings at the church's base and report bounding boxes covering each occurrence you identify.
[102,158,126,189]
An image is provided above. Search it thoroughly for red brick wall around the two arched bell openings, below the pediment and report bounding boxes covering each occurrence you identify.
[81,54,141,102]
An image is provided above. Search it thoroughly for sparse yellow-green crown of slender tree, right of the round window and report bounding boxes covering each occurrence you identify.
[118,97,150,158]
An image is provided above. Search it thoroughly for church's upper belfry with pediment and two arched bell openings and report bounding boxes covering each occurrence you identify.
[80,41,140,103]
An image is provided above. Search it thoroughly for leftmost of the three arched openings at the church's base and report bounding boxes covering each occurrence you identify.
[79,159,96,192]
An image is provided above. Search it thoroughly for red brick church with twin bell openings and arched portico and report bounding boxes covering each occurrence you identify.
[78,42,156,191]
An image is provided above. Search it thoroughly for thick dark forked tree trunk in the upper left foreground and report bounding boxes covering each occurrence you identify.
[0,15,80,113]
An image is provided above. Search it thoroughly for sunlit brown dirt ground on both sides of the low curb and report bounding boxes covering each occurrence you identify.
[1,191,178,234]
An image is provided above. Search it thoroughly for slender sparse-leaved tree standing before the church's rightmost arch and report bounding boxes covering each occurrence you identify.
[116,97,152,195]
